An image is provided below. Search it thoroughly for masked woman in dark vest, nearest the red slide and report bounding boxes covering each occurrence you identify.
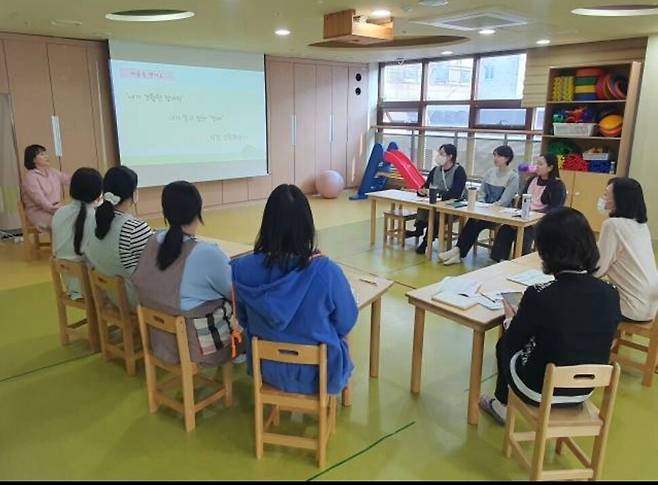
[405,143,466,254]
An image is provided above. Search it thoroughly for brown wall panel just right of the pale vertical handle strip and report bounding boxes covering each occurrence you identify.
[48,44,99,174]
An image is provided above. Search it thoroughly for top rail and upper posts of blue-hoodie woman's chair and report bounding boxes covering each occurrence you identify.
[251,337,327,400]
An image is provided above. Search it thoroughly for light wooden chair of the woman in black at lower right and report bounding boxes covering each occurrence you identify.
[504,364,620,480]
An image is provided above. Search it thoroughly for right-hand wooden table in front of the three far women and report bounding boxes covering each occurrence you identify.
[430,202,544,258]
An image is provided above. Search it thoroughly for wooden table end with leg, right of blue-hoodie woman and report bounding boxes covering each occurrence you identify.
[343,270,393,406]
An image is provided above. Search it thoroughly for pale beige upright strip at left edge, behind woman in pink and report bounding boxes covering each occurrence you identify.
[0,94,21,231]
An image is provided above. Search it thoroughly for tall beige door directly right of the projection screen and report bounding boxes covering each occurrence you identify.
[267,61,295,188]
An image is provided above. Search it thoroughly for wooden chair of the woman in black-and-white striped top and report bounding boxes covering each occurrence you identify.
[89,268,144,376]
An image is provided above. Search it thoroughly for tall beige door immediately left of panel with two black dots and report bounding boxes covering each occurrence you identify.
[331,66,349,180]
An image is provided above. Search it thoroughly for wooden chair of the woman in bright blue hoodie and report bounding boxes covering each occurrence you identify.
[251,337,336,468]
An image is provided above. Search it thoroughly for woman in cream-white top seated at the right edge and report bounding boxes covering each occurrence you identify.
[596,178,658,322]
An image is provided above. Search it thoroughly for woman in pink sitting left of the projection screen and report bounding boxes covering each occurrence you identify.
[22,145,71,231]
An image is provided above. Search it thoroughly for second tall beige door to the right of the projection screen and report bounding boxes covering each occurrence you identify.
[293,64,317,194]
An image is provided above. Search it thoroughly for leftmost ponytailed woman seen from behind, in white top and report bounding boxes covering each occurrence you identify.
[52,167,103,299]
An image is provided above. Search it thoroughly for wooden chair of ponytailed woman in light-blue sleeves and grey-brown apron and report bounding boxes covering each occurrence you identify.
[137,305,233,432]
